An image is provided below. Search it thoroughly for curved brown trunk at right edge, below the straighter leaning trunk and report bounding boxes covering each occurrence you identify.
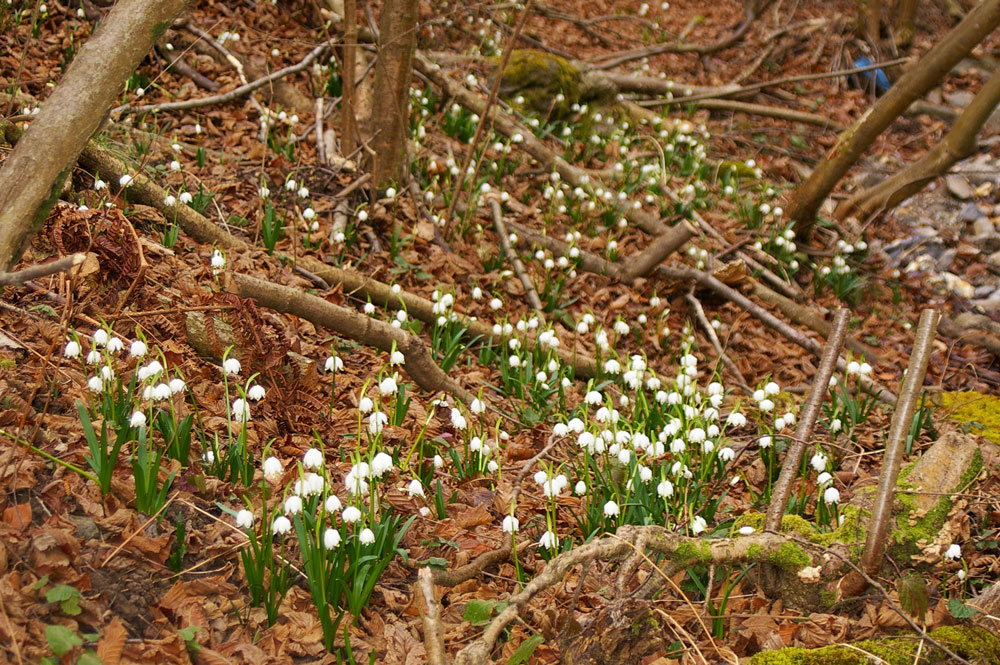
[836,65,1000,219]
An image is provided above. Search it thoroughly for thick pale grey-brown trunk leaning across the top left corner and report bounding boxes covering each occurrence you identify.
[0,0,185,270]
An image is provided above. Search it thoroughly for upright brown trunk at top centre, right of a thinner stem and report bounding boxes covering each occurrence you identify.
[370,0,420,188]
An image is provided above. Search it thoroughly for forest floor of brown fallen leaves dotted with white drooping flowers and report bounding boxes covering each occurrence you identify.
[0,0,1000,665]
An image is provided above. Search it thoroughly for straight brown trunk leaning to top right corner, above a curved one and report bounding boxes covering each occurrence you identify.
[788,0,1000,238]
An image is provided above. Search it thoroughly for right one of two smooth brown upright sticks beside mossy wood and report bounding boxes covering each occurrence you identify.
[861,309,940,575]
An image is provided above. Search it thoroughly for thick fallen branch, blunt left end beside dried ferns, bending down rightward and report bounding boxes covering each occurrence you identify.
[222,273,475,404]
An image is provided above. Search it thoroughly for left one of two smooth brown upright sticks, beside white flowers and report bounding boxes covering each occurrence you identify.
[764,309,850,531]
